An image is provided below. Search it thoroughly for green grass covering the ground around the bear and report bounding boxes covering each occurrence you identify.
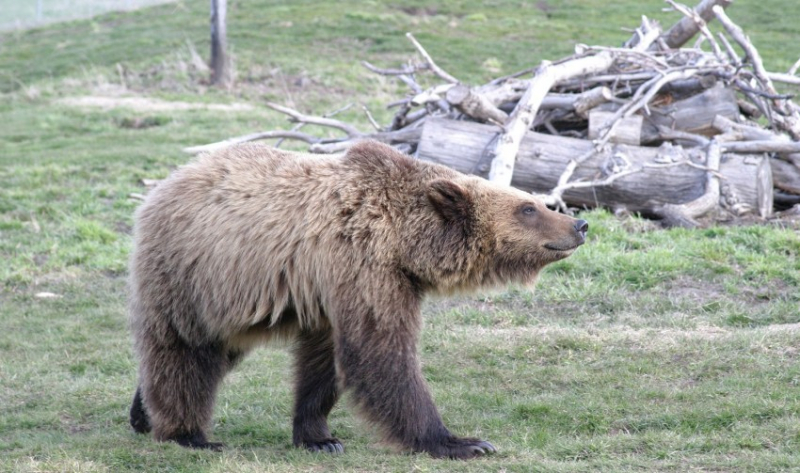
[0,0,800,472]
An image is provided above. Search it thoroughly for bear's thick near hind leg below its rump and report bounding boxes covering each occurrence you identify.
[138,328,234,450]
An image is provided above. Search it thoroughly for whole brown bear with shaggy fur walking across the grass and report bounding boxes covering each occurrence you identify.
[130,141,588,458]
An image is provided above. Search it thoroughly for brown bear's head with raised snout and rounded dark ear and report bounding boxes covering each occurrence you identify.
[407,175,589,293]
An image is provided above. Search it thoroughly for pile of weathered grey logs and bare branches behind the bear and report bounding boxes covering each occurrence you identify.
[185,0,800,227]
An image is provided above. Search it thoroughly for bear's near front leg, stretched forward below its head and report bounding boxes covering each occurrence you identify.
[335,300,496,459]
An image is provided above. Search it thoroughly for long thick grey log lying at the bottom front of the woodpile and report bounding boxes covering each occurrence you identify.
[417,118,772,216]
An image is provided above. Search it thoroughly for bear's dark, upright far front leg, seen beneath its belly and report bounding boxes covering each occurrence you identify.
[292,329,344,453]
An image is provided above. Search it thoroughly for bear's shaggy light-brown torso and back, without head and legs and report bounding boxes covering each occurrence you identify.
[131,143,446,337]
